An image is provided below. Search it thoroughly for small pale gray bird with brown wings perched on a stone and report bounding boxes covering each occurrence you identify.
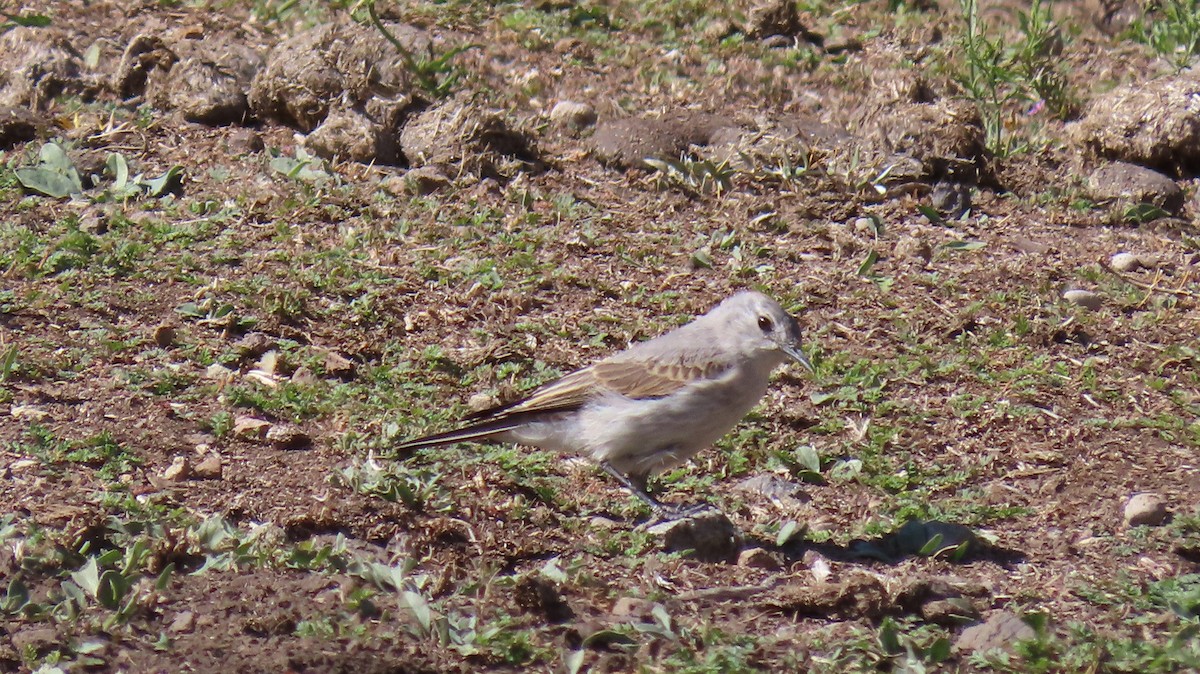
[396,291,812,516]
